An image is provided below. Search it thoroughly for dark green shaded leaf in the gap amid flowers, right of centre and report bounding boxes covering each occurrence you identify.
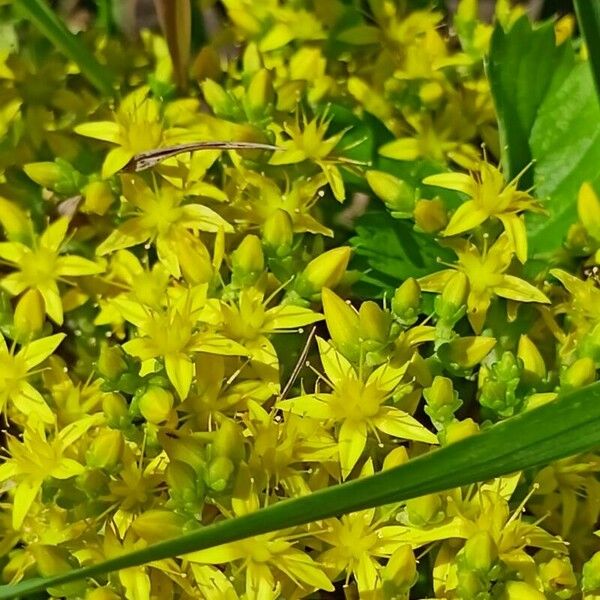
[350,211,454,287]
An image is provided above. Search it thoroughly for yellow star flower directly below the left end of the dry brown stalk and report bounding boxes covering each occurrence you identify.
[96,175,233,277]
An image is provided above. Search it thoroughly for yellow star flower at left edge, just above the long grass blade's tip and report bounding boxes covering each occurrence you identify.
[0,415,104,529]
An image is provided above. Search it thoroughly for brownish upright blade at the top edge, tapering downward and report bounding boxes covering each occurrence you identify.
[154,0,192,89]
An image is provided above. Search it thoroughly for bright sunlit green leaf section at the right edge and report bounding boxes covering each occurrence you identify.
[527,62,600,254]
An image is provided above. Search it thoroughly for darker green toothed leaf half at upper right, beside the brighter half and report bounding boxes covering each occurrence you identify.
[488,16,574,189]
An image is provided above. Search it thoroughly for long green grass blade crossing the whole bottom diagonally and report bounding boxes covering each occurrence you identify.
[0,382,600,600]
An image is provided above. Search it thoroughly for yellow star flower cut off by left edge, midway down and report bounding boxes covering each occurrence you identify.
[0,333,65,423]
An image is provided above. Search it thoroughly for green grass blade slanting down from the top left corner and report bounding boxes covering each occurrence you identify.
[15,0,114,96]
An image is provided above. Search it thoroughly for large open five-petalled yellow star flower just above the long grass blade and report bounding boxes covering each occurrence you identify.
[276,338,438,479]
